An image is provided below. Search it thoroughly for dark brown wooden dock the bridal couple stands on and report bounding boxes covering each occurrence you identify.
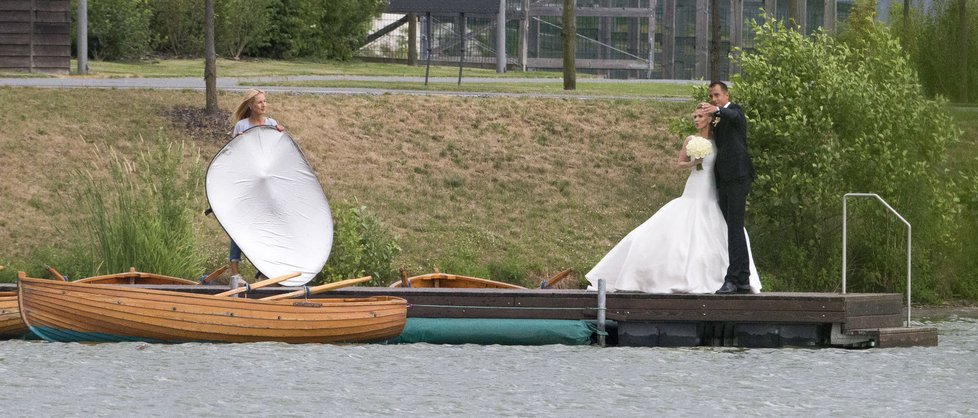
[0,285,938,348]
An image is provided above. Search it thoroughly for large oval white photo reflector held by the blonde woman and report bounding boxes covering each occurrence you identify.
[205,126,333,286]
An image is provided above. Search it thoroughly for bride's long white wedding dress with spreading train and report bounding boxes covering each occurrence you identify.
[585,141,761,293]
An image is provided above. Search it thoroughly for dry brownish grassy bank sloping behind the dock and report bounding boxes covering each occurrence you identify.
[0,88,978,291]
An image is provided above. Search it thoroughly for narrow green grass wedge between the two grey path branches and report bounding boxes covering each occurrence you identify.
[255,77,690,98]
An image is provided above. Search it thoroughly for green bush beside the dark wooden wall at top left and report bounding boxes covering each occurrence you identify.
[83,0,153,61]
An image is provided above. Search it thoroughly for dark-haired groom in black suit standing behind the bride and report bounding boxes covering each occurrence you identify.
[698,81,754,294]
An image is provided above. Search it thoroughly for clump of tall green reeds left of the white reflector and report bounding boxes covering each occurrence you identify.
[49,137,204,279]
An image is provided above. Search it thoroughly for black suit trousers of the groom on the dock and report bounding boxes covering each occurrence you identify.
[717,176,753,286]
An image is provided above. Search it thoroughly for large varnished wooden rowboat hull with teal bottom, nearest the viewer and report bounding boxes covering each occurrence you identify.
[17,275,407,343]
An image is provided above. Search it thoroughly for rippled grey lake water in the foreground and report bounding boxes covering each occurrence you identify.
[0,315,978,417]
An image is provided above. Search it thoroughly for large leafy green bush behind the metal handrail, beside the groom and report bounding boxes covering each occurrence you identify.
[731,13,962,301]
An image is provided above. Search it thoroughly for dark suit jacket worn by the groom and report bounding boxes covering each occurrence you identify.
[713,103,754,185]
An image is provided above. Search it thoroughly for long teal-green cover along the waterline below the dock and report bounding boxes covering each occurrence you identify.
[388,318,597,345]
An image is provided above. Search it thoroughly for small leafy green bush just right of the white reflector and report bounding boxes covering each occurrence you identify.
[319,203,401,285]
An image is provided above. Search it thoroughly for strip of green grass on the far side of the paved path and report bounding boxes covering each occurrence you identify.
[71,59,572,78]
